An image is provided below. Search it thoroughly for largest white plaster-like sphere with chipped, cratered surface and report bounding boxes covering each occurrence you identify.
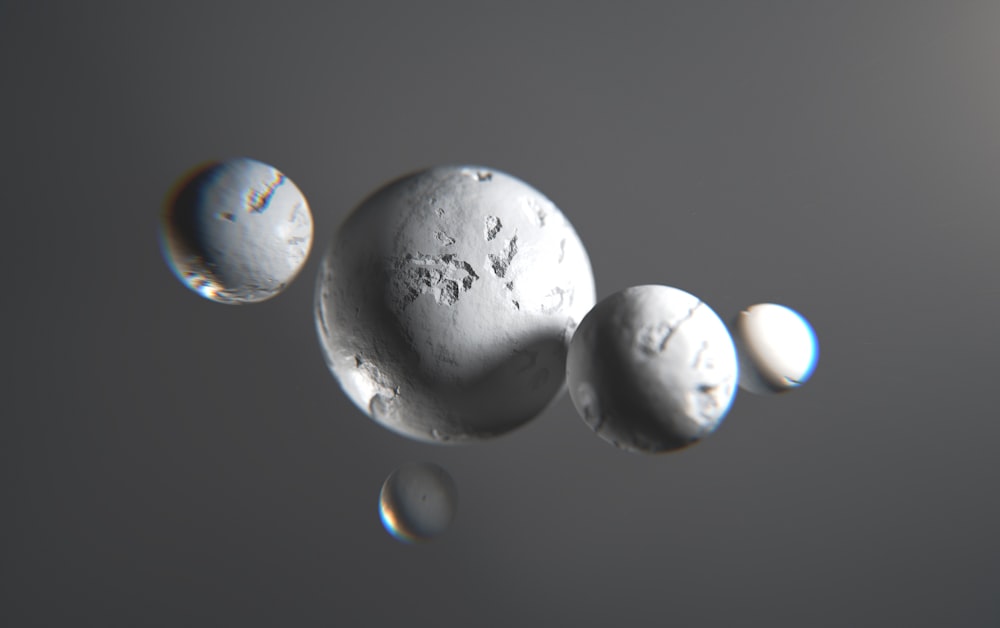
[316,166,595,443]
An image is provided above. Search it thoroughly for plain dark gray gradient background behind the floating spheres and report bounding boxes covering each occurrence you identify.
[0,0,1000,627]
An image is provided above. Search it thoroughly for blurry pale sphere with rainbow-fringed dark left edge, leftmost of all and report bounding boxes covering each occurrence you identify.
[162,159,313,303]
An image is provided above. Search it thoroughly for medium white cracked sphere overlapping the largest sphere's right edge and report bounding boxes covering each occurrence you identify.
[566,285,739,453]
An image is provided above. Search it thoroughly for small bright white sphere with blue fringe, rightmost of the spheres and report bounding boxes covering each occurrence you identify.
[733,303,819,395]
